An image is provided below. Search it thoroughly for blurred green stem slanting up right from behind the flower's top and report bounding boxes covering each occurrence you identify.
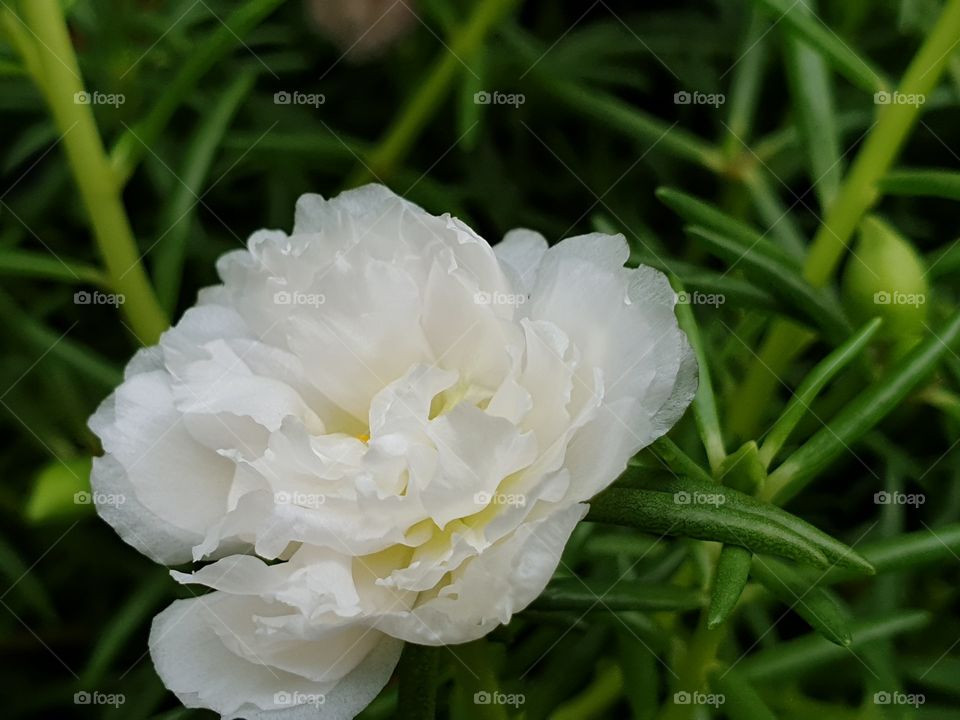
[347,0,518,187]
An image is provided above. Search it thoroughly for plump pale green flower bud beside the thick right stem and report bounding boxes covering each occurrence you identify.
[842,215,929,346]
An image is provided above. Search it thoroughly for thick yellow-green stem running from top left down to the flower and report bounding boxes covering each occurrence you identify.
[23,0,168,345]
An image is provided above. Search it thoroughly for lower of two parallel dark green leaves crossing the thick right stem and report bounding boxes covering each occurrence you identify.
[686,226,851,340]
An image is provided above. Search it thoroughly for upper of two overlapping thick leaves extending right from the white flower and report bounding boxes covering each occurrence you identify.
[624,473,873,575]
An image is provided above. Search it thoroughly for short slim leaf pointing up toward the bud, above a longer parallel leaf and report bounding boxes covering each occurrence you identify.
[760,318,882,467]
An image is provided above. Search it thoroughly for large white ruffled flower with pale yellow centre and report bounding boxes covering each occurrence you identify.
[91,185,696,719]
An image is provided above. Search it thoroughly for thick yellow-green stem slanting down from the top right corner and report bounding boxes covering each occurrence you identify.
[729,0,960,437]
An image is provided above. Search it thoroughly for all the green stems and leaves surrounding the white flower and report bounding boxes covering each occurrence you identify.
[0,0,960,720]
